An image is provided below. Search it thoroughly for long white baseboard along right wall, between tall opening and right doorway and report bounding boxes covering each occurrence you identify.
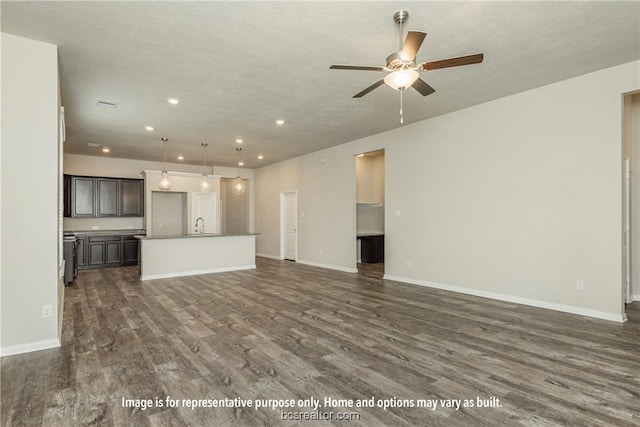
[384,274,626,323]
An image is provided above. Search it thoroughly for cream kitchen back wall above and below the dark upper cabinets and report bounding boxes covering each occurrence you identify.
[64,154,254,230]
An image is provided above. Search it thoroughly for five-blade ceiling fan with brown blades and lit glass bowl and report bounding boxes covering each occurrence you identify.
[329,10,484,123]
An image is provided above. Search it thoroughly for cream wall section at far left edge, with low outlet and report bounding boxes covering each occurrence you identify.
[0,33,60,355]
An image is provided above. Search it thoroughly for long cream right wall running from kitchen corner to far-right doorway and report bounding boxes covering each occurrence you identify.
[255,61,640,320]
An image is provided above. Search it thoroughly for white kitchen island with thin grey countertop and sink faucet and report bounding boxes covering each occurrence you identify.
[136,233,256,280]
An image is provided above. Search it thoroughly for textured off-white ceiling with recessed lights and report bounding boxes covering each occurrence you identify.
[1,1,640,168]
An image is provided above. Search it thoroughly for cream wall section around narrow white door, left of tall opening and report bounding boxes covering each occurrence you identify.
[255,145,356,271]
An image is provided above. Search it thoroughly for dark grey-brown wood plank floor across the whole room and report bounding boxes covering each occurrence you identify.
[0,258,640,426]
